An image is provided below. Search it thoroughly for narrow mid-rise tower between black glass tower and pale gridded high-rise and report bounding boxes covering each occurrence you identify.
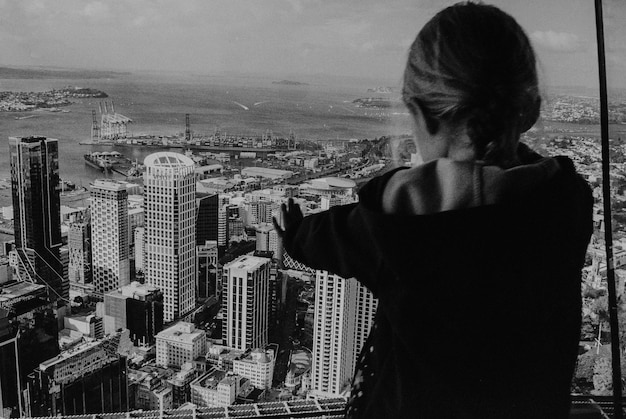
[67,222,92,284]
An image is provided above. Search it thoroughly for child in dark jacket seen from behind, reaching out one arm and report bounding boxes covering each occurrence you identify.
[275,3,593,419]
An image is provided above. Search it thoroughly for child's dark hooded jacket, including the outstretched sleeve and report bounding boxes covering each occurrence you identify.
[284,146,593,419]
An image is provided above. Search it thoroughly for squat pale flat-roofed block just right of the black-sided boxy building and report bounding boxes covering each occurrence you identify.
[156,322,206,368]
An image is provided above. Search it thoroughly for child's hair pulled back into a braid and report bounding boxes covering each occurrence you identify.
[402,2,541,166]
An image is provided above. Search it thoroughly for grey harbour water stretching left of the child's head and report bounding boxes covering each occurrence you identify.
[0,73,409,189]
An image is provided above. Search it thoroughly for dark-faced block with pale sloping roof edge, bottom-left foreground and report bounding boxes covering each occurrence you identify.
[26,332,130,416]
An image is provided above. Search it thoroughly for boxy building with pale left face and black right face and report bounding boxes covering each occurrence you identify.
[104,282,163,345]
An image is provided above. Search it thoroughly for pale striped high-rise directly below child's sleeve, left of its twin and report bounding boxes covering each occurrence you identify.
[311,270,357,396]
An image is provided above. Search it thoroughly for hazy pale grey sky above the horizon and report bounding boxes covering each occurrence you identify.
[0,0,626,87]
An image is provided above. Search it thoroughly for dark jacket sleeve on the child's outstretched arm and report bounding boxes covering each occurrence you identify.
[283,203,382,293]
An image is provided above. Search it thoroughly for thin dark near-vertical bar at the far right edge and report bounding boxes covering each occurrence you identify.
[595,0,623,419]
